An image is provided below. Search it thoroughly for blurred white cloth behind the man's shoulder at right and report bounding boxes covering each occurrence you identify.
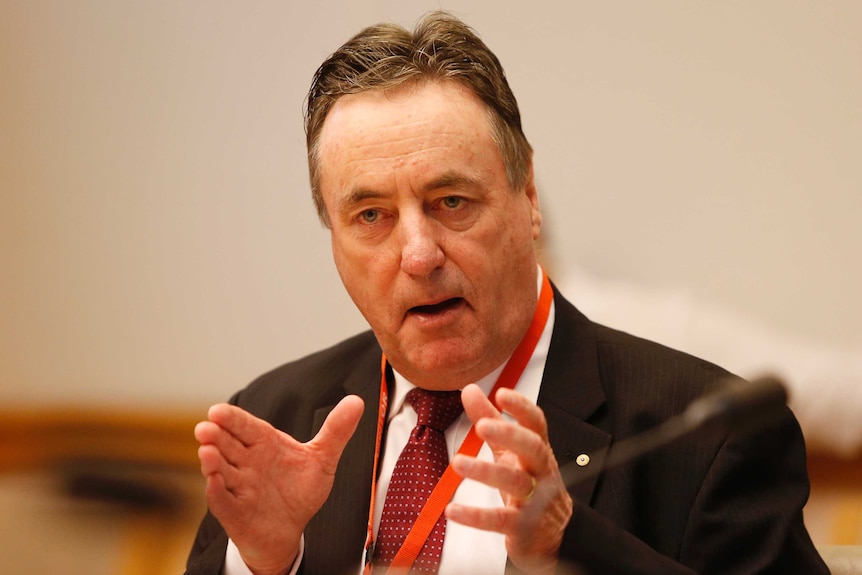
[557,266,862,457]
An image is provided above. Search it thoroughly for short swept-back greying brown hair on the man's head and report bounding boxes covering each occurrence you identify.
[304,11,533,227]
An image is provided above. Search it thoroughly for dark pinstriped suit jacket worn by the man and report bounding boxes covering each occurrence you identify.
[187,292,828,575]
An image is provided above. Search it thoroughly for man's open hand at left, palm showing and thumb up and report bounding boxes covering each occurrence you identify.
[195,396,364,575]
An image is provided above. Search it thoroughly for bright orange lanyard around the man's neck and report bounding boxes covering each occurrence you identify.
[363,270,554,575]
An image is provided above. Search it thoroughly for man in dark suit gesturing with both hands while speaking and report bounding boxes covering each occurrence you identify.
[188,13,827,575]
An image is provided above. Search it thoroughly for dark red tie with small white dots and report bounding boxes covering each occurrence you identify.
[374,387,464,575]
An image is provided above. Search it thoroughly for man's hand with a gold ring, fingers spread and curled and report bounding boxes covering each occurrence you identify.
[446,385,572,574]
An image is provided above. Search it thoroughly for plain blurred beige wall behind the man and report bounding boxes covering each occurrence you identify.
[0,0,862,407]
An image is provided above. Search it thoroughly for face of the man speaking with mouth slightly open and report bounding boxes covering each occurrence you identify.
[320,81,541,389]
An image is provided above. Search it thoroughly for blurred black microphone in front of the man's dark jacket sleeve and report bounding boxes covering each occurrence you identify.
[560,375,787,487]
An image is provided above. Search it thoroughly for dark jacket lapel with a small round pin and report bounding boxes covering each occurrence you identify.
[538,288,612,504]
